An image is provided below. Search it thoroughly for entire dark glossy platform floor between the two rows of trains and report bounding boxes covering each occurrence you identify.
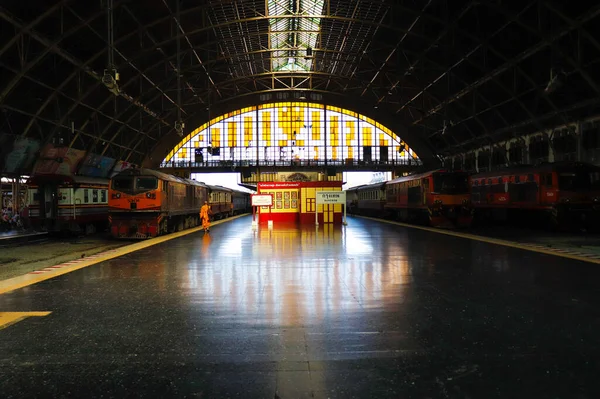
[0,217,600,399]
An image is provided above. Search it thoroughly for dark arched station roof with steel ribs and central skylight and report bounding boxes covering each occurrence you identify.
[0,0,600,166]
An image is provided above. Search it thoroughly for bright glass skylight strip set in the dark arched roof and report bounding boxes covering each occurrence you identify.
[267,0,325,71]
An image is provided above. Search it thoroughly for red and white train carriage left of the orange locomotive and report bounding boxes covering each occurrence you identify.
[27,175,108,234]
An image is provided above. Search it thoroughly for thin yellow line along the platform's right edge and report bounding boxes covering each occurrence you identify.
[355,215,600,264]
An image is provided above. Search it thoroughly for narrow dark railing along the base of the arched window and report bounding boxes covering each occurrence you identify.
[160,159,423,168]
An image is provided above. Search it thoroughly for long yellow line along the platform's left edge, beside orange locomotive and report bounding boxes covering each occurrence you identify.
[0,213,248,294]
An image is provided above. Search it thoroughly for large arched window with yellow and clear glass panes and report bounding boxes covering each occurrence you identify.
[162,102,418,167]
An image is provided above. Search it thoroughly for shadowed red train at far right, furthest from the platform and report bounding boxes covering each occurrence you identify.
[470,162,600,228]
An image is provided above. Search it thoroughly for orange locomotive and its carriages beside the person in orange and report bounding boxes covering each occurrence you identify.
[108,169,250,238]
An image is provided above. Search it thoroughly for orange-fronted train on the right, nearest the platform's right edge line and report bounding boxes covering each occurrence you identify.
[346,169,472,227]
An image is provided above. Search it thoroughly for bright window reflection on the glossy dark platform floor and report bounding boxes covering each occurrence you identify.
[187,225,409,326]
